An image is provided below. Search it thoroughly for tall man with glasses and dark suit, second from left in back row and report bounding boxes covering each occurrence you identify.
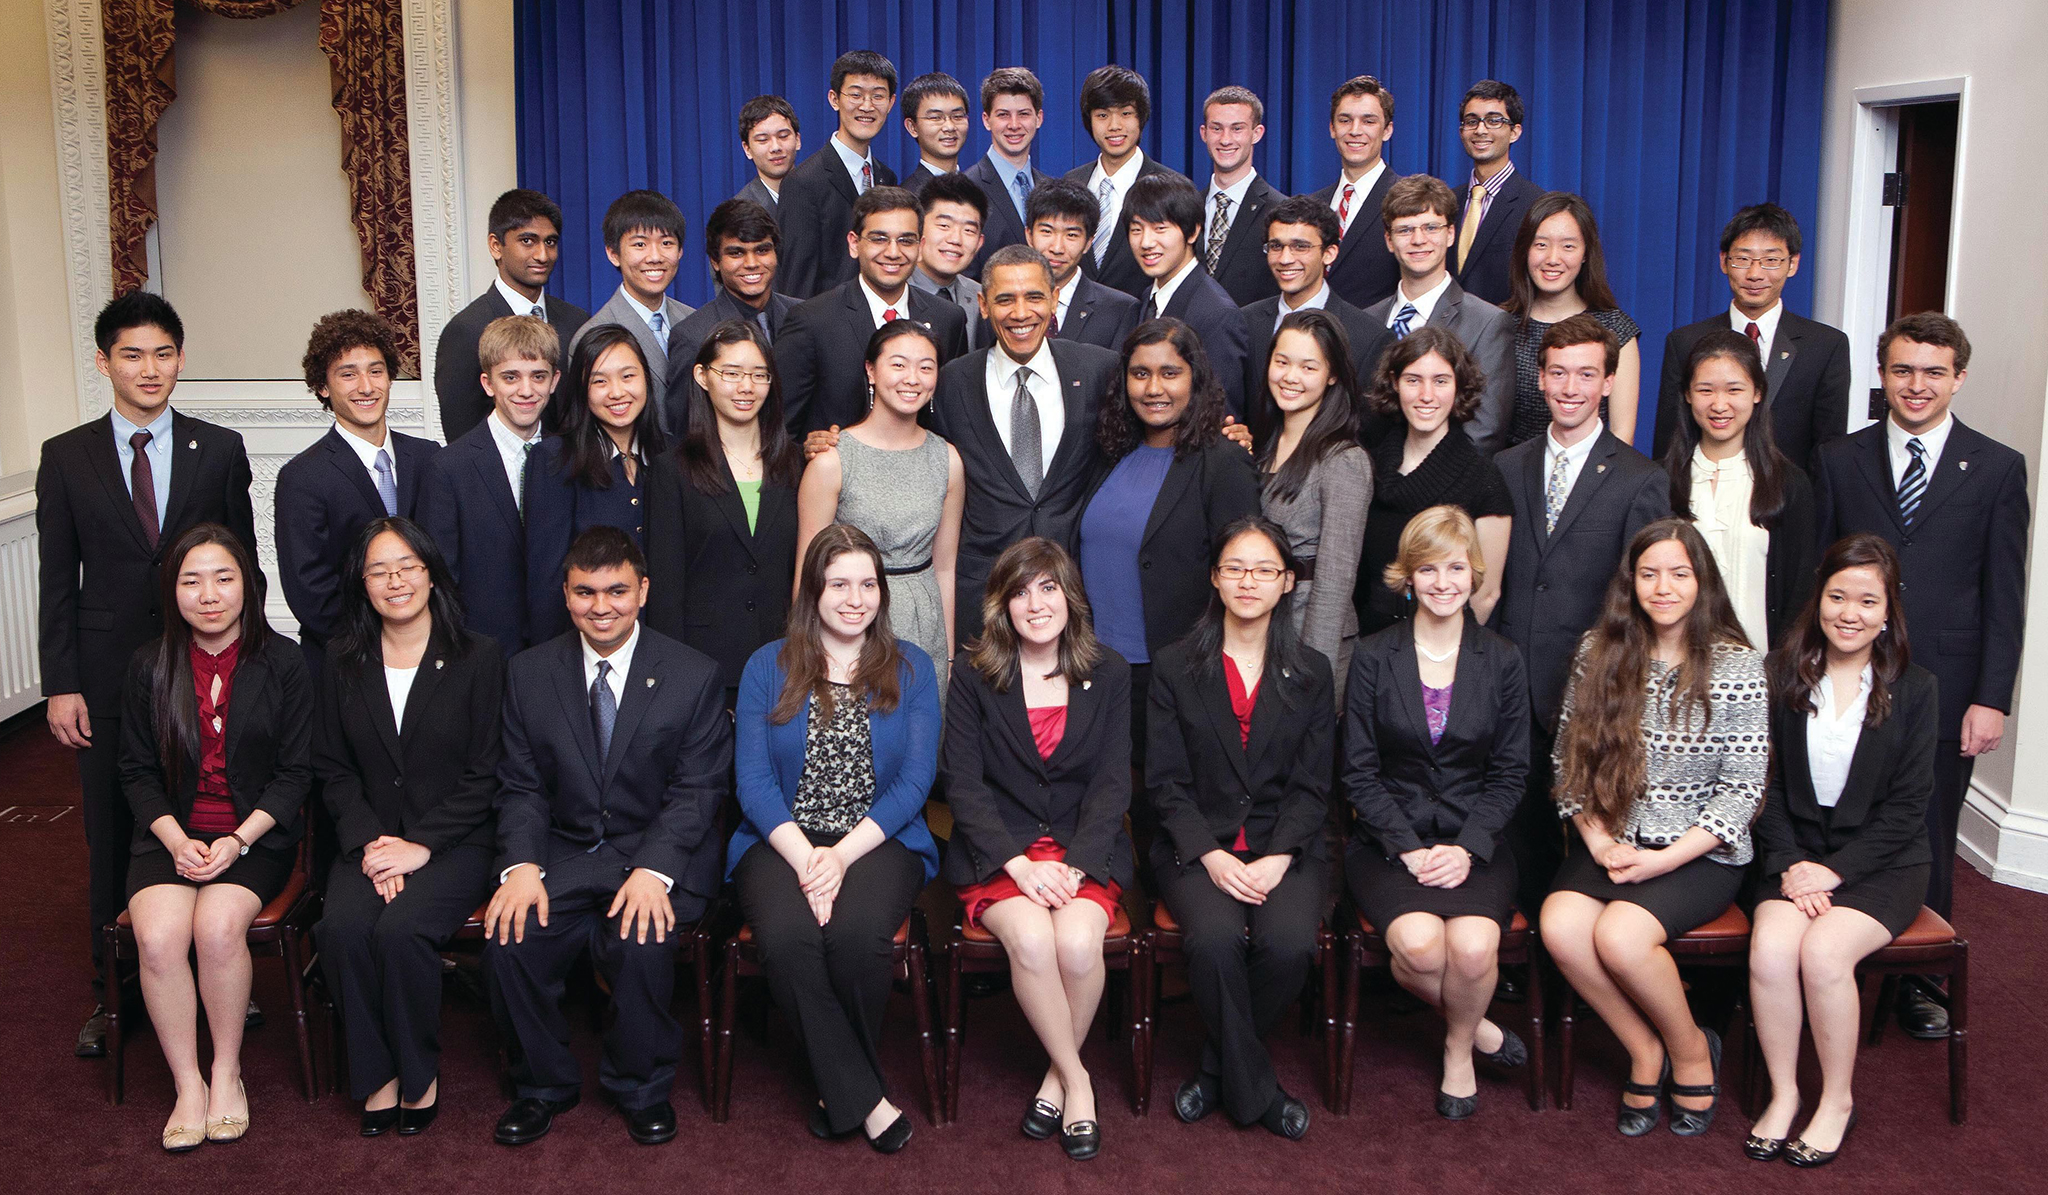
[776,49,895,299]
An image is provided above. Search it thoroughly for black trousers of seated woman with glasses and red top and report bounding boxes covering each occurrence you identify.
[1153,842,1329,1125]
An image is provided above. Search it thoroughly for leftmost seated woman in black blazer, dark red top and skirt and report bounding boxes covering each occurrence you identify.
[121,523,313,1154]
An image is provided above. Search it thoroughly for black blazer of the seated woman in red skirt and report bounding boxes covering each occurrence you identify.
[940,648,1133,888]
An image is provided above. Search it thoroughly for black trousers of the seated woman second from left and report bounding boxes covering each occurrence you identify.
[313,844,492,1101]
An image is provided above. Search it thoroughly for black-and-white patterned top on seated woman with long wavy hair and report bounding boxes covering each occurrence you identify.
[1552,644,1772,867]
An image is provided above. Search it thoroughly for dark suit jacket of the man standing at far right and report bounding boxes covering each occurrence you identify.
[1812,416,2032,744]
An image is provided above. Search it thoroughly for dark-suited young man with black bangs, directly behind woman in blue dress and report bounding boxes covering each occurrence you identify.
[1124,176,1247,418]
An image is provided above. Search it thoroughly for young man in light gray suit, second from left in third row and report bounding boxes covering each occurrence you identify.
[567,191,696,437]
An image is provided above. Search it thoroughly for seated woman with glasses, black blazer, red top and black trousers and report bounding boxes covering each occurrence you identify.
[1145,514,1337,1140]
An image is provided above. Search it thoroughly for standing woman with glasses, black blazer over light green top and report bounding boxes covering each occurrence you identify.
[647,320,803,709]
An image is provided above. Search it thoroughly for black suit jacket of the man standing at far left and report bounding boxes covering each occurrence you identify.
[35,410,258,719]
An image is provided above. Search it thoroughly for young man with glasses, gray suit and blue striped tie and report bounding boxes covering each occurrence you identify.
[1366,174,1516,457]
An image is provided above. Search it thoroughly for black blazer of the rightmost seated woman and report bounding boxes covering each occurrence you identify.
[1751,664,1942,896]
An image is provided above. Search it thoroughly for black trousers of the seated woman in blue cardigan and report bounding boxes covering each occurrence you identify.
[733,834,924,1134]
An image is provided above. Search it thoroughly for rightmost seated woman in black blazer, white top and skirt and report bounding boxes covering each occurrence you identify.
[1743,535,1939,1166]
